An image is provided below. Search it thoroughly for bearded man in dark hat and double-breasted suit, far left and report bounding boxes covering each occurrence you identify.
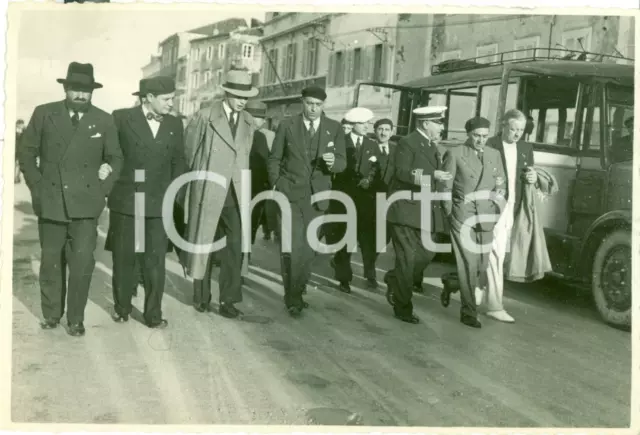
[18,62,122,336]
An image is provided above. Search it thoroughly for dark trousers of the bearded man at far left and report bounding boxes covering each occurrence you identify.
[38,219,98,324]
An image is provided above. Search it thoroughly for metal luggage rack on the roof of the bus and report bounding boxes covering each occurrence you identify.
[431,48,634,75]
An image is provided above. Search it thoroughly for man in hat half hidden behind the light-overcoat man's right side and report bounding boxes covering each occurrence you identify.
[245,100,276,243]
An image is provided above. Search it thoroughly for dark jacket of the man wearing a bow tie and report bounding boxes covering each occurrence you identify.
[108,106,185,217]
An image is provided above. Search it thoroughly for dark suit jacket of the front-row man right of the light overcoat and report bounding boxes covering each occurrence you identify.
[267,114,347,211]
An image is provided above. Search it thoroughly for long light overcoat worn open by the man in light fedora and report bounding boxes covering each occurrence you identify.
[180,101,255,279]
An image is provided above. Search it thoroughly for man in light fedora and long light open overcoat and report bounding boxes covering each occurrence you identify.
[180,70,258,318]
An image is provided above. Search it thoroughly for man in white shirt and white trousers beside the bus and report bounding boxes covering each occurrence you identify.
[476,109,538,323]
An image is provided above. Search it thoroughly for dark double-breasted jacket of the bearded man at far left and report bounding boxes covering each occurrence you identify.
[17,101,122,222]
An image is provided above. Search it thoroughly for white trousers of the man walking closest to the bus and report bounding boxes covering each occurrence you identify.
[485,203,513,311]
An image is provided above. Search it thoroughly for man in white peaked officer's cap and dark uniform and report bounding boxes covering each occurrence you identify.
[385,106,450,324]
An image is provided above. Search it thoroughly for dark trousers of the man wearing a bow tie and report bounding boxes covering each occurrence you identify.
[109,211,168,323]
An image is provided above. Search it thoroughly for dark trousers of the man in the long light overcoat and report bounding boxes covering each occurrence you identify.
[193,201,243,305]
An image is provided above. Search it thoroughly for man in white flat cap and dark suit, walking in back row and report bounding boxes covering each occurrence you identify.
[327,107,377,293]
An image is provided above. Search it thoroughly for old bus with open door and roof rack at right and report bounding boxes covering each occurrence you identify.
[353,49,634,328]
